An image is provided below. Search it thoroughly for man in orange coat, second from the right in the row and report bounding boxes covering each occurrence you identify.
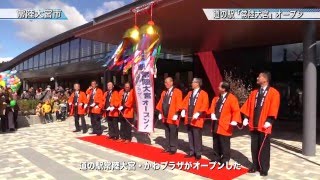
[208,81,242,164]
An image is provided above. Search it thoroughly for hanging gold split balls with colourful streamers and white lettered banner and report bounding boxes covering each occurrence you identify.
[100,2,161,133]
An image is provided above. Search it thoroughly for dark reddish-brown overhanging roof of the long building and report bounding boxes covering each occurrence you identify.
[0,0,320,71]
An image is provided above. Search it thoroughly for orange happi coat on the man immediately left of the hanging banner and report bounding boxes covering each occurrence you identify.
[119,89,135,118]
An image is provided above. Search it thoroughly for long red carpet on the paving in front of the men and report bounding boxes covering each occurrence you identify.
[79,136,248,180]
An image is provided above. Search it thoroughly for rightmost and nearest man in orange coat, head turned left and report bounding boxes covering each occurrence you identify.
[241,72,280,176]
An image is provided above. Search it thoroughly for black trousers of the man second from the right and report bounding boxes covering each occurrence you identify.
[212,132,230,163]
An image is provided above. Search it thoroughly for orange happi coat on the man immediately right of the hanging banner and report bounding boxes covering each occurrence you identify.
[156,88,182,126]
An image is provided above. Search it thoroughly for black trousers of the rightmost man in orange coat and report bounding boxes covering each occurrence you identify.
[251,131,270,172]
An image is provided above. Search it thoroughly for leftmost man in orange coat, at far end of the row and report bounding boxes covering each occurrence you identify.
[68,83,88,134]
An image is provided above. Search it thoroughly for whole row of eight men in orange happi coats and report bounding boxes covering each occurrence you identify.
[69,72,280,176]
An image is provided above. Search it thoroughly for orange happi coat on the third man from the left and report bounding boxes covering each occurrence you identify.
[103,91,121,117]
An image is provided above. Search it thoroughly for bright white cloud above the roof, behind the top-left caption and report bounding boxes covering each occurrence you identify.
[15,0,87,43]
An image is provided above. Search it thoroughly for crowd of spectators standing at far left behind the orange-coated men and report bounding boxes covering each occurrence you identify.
[0,85,71,132]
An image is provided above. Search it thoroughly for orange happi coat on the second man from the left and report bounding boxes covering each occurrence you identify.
[86,88,104,114]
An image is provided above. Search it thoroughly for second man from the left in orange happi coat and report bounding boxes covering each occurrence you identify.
[86,81,103,136]
